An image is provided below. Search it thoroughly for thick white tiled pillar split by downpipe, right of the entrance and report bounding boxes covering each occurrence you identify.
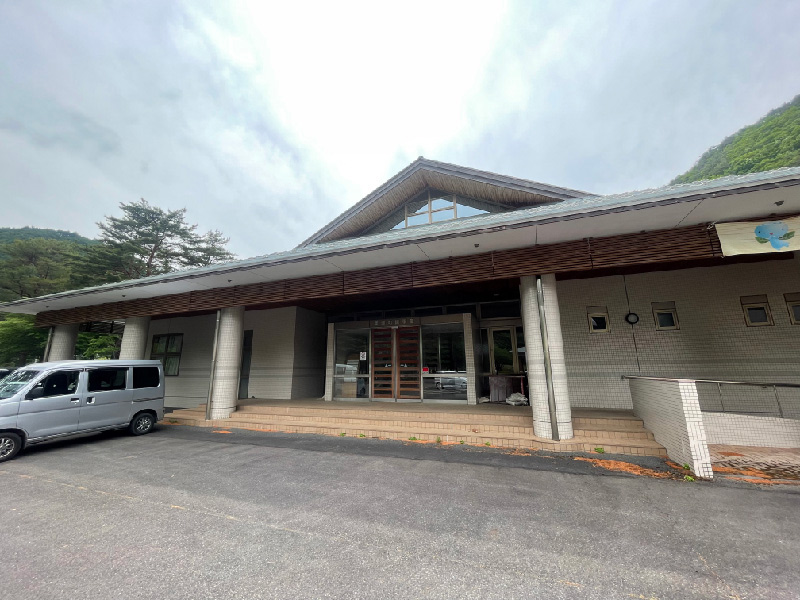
[520,274,573,440]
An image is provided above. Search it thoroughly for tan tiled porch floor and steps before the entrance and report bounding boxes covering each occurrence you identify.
[164,399,666,456]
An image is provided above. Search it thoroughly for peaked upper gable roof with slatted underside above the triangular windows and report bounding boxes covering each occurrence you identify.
[299,156,591,248]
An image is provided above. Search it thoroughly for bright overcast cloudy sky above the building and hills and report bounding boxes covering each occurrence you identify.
[0,0,800,257]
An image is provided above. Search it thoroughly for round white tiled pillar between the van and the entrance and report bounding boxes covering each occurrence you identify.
[210,306,244,419]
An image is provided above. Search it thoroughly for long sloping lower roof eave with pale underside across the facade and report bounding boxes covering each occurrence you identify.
[0,167,800,314]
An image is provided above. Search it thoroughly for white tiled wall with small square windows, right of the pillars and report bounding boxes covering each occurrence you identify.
[558,260,800,409]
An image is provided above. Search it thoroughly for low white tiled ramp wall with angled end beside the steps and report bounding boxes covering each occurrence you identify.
[627,379,714,479]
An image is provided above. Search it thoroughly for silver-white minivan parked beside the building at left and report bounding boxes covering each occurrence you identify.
[0,360,164,462]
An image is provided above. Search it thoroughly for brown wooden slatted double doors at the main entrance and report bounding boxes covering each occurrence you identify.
[372,327,422,401]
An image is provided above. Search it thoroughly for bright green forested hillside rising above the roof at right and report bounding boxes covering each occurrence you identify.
[671,95,800,183]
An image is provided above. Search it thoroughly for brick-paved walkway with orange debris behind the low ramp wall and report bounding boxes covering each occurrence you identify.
[708,444,800,485]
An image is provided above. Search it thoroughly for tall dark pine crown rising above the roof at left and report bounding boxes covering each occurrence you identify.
[94,198,234,281]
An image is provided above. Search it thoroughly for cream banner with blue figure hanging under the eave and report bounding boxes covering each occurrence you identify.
[714,217,800,256]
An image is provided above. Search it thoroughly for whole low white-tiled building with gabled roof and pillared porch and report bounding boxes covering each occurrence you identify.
[0,158,800,476]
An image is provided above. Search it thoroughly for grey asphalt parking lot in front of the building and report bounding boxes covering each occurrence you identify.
[0,426,800,600]
